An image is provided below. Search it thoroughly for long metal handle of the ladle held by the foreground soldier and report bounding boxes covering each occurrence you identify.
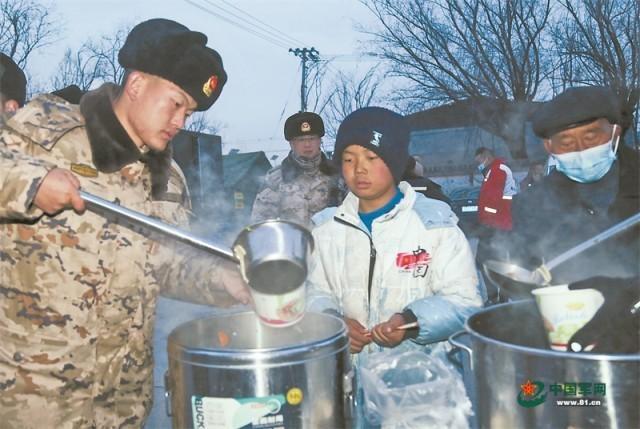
[80,191,238,263]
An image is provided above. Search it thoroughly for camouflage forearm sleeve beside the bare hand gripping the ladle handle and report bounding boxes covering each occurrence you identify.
[0,144,55,220]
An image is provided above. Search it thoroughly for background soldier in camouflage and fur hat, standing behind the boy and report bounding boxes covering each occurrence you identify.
[251,112,346,226]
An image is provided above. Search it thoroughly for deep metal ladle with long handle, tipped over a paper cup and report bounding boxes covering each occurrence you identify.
[80,191,313,293]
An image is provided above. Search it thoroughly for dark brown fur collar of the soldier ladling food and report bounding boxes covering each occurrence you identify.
[80,84,171,198]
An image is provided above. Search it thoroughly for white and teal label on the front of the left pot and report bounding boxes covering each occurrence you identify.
[191,395,286,429]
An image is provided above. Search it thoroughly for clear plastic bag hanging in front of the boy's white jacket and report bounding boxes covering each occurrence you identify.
[360,349,472,429]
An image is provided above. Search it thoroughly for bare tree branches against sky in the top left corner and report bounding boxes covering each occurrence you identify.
[0,0,58,69]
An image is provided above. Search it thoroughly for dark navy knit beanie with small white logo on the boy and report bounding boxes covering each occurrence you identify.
[333,107,410,183]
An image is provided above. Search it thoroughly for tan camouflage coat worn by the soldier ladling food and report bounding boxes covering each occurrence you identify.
[0,86,236,429]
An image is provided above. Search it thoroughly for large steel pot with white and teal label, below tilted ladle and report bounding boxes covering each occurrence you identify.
[165,312,353,429]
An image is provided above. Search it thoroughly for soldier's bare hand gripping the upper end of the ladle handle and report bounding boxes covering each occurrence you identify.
[33,168,85,215]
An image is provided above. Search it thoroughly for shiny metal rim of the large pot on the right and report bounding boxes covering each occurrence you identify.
[464,299,640,362]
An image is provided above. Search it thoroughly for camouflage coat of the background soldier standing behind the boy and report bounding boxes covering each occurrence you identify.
[251,153,346,226]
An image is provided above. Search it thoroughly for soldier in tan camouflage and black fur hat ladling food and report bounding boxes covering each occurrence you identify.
[0,19,249,429]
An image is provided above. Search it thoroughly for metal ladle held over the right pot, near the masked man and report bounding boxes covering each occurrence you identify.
[483,213,640,298]
